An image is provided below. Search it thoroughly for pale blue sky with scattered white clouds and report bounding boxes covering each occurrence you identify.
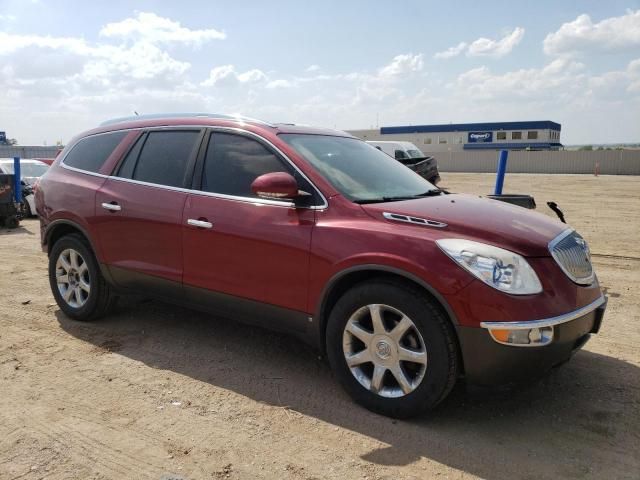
[0,0,640,145]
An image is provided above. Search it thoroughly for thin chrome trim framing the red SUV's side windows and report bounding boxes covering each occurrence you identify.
[60,125,329,210]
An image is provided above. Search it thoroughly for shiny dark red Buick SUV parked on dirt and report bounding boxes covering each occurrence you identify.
[37,115,606,417]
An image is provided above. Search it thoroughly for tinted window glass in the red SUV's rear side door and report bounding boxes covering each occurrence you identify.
[132,130,200,187]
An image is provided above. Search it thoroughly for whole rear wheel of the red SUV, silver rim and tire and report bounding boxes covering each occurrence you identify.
[49,234,116,320]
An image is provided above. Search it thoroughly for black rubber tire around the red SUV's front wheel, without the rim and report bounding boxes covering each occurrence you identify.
[326,279,459,418]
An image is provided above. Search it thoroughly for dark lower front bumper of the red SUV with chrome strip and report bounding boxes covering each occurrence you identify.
[458,296,607,385]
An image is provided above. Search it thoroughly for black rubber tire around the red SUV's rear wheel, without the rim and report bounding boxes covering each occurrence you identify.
[49,234,117,321]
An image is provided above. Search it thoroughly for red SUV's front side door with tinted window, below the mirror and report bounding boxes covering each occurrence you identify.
[182,131,322,329]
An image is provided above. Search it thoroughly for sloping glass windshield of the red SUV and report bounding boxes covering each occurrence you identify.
[280,134,437,203]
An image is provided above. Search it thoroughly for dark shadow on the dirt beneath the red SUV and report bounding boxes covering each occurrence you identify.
[56,297,640,479]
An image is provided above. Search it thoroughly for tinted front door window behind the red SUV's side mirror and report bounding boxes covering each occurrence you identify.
[202,133,291,197]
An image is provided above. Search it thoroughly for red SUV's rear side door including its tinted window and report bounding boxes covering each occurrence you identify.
[96,128,202,296]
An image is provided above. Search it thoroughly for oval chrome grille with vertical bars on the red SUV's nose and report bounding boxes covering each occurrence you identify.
[549,230,593,285]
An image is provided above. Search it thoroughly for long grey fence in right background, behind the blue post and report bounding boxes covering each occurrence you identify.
[425,150,640,175]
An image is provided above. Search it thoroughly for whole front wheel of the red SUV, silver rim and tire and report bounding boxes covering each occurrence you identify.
[326,280,458,418]
